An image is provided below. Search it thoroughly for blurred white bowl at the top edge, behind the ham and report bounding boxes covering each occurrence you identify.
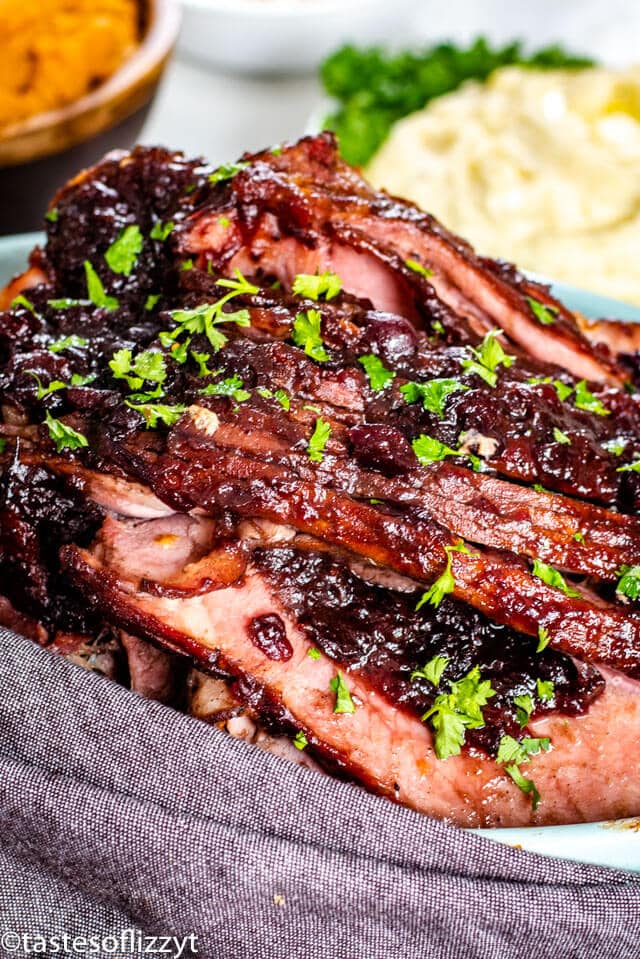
[178,0,415,74]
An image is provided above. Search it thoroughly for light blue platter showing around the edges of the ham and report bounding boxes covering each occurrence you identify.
[0,233,640,872]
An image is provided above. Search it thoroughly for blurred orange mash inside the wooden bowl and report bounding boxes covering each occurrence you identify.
[0,0,139,130]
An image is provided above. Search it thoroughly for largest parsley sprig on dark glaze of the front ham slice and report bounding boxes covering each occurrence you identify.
[421,666,495,759]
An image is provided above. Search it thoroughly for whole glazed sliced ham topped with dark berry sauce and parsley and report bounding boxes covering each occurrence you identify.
[0,134,640,825]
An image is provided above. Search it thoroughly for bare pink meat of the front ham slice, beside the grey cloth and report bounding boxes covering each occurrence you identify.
[61,531,640,826]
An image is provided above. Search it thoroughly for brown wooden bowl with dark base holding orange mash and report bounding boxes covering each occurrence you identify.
[0,0,180,234]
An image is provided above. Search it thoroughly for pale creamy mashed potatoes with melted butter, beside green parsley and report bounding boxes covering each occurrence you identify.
[366,67,640,304]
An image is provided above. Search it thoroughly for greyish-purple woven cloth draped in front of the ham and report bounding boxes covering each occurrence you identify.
[0,630,640,959]
